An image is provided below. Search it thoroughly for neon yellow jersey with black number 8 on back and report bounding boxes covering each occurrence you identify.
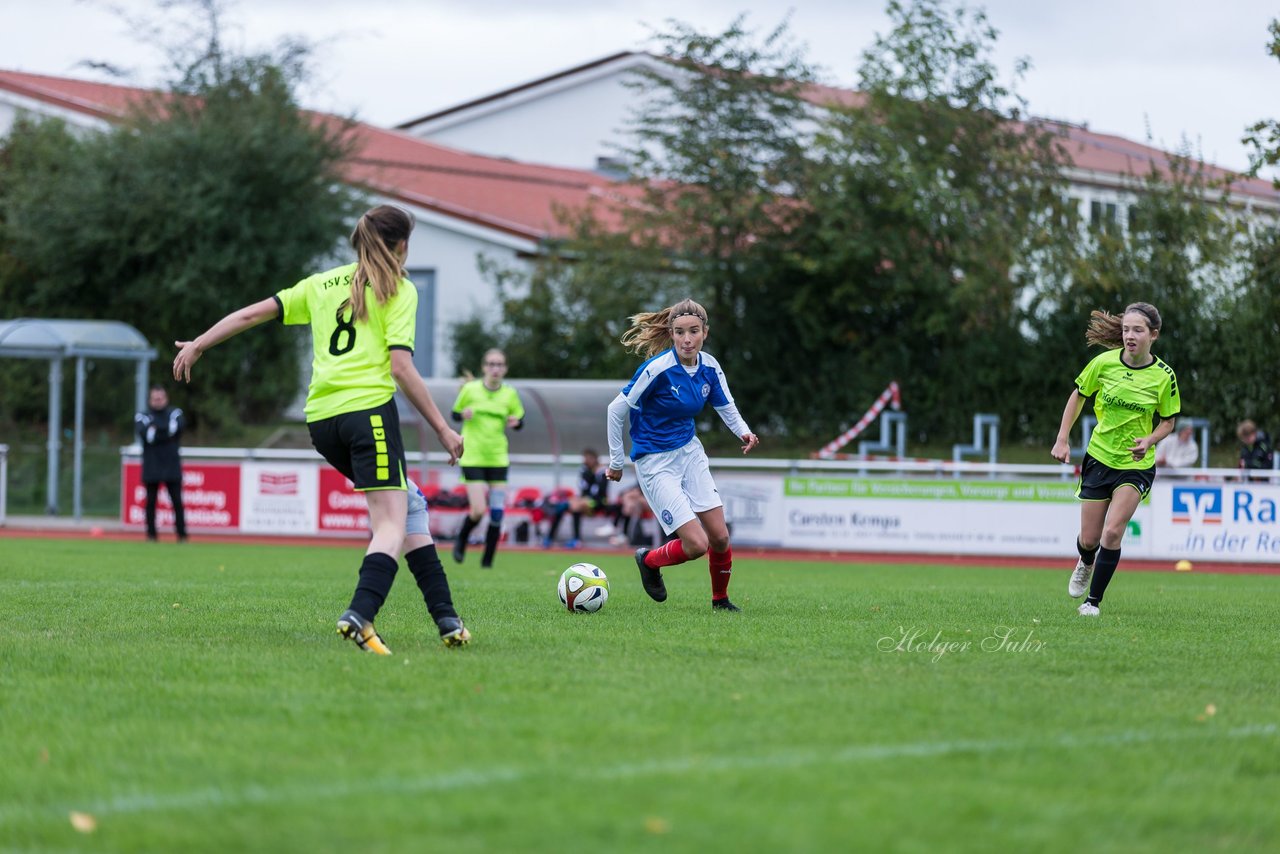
[275,264,417,423]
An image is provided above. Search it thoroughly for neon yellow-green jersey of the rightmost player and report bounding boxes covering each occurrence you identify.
[1075,350,1181,469]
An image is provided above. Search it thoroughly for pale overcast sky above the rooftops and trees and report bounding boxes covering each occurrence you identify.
[0,0,1280,175]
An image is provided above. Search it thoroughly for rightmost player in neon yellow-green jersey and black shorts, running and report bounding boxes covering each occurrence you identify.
[1050,302,1181,617]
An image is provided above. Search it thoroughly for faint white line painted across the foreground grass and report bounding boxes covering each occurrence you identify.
[0,723,1280,825]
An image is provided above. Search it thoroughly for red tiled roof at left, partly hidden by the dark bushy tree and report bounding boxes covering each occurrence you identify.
[0,70,626,241]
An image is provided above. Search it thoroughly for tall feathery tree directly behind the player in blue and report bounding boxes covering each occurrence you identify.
[473,18,814,409]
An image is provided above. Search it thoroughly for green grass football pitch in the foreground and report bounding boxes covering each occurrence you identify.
[0,539,1280,851]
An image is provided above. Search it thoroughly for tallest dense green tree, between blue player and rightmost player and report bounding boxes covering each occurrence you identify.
[803,0,1071,440]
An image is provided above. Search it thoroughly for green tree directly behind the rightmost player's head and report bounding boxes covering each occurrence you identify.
[1028,155,1249,438]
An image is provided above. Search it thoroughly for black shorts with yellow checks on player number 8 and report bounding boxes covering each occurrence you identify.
[307,399,406,492]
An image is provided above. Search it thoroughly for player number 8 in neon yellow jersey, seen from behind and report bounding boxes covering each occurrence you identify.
[173,205,471,656]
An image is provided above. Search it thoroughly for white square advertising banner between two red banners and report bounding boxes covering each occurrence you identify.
[241,461,320,536]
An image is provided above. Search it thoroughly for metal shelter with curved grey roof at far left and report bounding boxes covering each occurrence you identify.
[0,318,156,520]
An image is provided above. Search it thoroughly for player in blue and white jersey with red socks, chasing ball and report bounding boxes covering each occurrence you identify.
[605,300,760,611]
